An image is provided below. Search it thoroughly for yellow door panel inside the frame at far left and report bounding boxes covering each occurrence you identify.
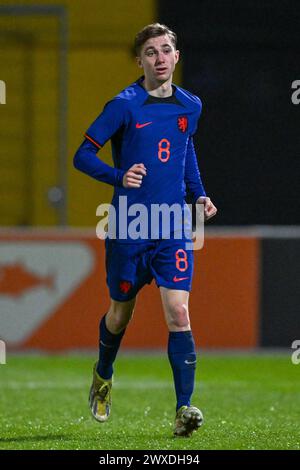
[0,15,58,225]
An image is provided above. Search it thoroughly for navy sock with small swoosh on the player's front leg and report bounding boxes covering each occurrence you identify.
[168,331,196,411]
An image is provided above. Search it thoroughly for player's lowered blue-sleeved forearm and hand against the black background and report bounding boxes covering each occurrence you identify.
[184,136,217,220]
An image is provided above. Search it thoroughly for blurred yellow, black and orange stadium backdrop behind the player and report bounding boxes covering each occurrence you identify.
[0,0,300,450]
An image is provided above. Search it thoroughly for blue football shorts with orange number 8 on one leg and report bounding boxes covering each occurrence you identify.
[105,239,194,301]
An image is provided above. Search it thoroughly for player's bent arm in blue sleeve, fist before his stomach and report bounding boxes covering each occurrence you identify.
[73,99,146,188]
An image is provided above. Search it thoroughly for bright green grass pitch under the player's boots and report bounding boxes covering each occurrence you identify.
[0,353,300,450]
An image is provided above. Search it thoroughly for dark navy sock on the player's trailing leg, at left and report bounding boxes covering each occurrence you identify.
[97,315,126,380]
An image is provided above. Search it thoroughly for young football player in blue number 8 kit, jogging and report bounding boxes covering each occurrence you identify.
[74,23,217,436]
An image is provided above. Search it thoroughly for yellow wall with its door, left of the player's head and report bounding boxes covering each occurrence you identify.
[0,0,182,226]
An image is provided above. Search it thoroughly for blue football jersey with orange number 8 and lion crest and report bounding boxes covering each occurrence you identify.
[85,77,205,241]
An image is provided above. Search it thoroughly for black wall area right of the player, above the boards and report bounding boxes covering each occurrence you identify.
[159,0,300,225]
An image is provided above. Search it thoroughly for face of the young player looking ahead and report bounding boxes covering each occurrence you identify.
[137,34,179,83]
